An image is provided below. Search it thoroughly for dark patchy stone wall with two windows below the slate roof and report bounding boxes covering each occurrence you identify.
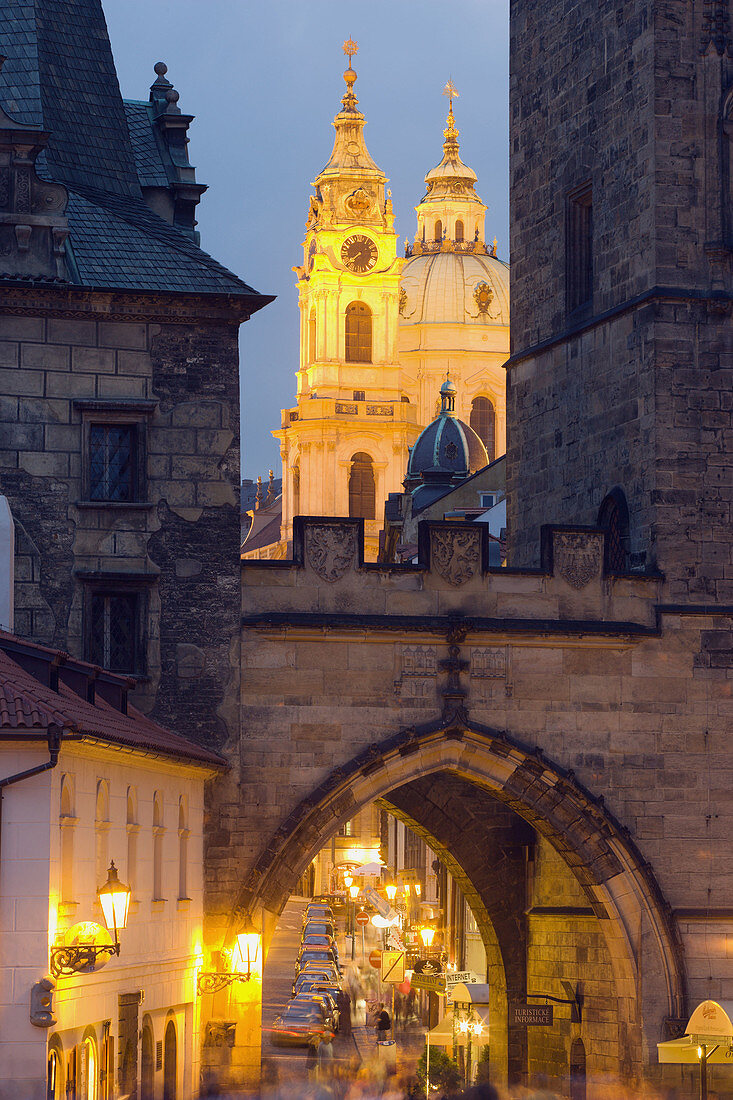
[0,290,243,746]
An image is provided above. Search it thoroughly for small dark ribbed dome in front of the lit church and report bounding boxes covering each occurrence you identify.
[405,378,489,509]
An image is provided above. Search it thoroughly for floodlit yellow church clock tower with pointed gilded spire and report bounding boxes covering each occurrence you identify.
[273,41,420,557]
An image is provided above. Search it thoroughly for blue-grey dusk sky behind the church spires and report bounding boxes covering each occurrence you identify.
[103,0,508,479]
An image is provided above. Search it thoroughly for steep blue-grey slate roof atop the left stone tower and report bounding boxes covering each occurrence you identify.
[0,0,265,301]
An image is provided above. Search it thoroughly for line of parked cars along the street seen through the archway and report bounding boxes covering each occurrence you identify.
[272,898,341,1046]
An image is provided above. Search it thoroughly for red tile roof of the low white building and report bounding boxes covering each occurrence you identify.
[0,635,226,767]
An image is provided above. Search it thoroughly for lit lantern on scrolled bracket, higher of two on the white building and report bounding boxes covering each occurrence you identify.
[51,860,132,978]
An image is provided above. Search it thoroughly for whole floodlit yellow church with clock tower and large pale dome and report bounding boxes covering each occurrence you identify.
[242,50,510,559]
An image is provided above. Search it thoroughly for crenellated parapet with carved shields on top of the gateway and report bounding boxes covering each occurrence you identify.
[243,517,663,645]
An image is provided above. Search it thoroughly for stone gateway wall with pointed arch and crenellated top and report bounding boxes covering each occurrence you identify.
[225,520,733,1074]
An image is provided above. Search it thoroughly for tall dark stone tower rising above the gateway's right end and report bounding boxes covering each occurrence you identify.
[507,0,733,603]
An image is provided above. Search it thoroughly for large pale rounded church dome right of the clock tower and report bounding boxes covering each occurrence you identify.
[400,251,510,326]
